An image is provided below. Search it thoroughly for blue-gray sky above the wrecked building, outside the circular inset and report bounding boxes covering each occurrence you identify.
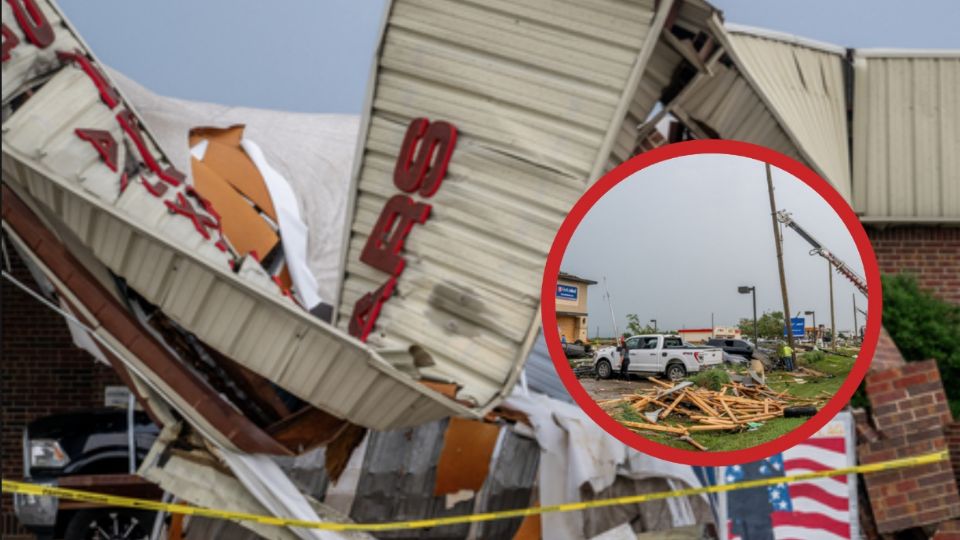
[60,0,960,113]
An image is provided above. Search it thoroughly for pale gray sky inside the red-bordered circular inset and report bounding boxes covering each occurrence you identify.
[563,155,867,337]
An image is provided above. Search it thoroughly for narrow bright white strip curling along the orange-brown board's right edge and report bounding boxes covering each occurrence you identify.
[240,137,321,310]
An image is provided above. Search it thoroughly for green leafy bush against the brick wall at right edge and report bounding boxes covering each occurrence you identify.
[881,274,960,415]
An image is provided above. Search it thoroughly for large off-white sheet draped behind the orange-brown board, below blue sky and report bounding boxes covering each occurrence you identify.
[107,68,360,305]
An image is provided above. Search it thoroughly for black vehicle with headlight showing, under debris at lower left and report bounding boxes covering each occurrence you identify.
[14,408,159,540]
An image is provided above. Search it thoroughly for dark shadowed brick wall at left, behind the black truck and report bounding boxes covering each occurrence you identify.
[0,238,122,538]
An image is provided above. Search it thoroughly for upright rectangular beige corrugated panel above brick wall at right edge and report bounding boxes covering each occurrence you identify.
[853,51,960,222]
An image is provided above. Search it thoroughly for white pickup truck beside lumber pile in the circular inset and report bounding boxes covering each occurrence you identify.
[593,334,723,381]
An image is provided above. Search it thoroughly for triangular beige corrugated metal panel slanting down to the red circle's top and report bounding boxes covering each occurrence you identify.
[728,31,850,200]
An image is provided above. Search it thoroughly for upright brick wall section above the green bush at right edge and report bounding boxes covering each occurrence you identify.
[867,226,960,304]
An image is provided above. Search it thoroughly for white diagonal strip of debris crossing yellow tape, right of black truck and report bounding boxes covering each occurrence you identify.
[217,448,348,540]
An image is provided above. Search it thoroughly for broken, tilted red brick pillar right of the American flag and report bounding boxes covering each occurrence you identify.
[858,360,960,533]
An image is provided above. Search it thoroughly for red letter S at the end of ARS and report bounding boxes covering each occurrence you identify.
[393,118,457,197]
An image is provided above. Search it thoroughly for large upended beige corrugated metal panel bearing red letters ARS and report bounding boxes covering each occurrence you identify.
[338,0,671,407]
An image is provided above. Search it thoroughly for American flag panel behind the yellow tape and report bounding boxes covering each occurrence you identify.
[721,413,858,540]
